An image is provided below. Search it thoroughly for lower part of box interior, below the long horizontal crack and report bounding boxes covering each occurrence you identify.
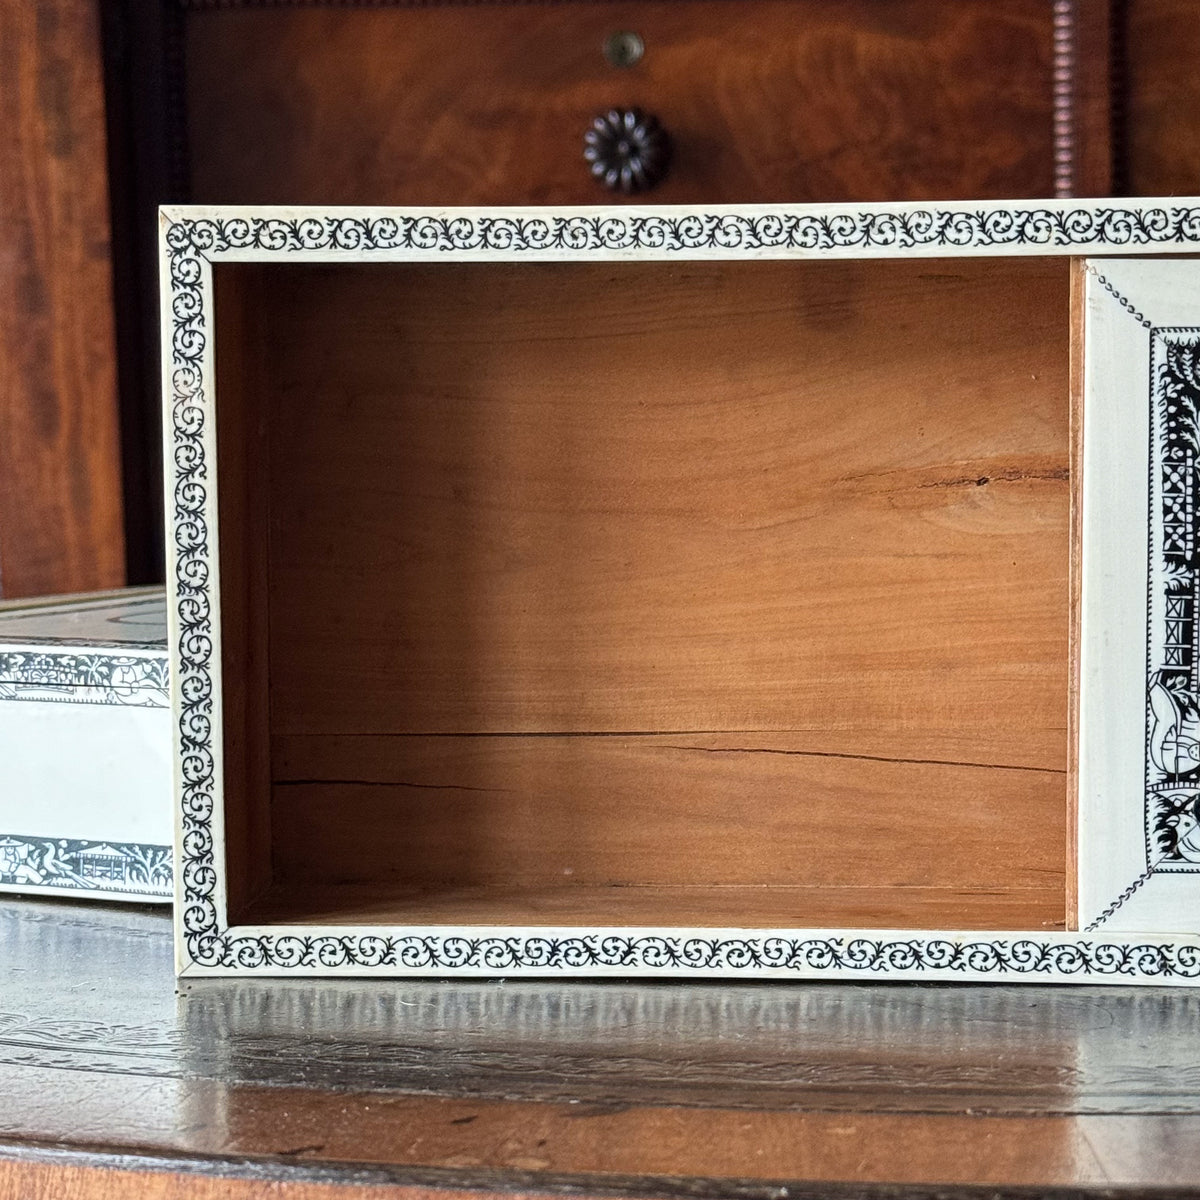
[269,734,1066,929]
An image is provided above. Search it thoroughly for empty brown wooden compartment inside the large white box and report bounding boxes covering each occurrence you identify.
[214,258,1070,930]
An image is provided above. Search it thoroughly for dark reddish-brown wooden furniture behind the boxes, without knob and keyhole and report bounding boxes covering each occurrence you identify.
[11,0,1200,596]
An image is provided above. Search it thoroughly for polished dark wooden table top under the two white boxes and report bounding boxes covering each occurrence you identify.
[0,899,1200,1200]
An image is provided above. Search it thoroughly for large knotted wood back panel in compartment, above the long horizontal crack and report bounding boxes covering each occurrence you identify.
[248,256,1069,739]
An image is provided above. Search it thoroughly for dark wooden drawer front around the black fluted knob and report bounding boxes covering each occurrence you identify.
[185,0,1089,204]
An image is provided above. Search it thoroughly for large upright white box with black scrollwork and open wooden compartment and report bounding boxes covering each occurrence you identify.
[162,199,1200,982]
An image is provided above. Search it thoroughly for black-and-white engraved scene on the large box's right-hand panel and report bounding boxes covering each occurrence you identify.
[1146,338,1200,870]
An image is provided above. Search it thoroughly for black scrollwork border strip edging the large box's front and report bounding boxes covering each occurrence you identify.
[163,202,1200,982]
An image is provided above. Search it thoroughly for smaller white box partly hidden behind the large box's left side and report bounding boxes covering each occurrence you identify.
[0,588,172,904]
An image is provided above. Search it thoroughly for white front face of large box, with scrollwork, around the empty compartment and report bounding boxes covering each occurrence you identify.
[161,199,1200,984]
